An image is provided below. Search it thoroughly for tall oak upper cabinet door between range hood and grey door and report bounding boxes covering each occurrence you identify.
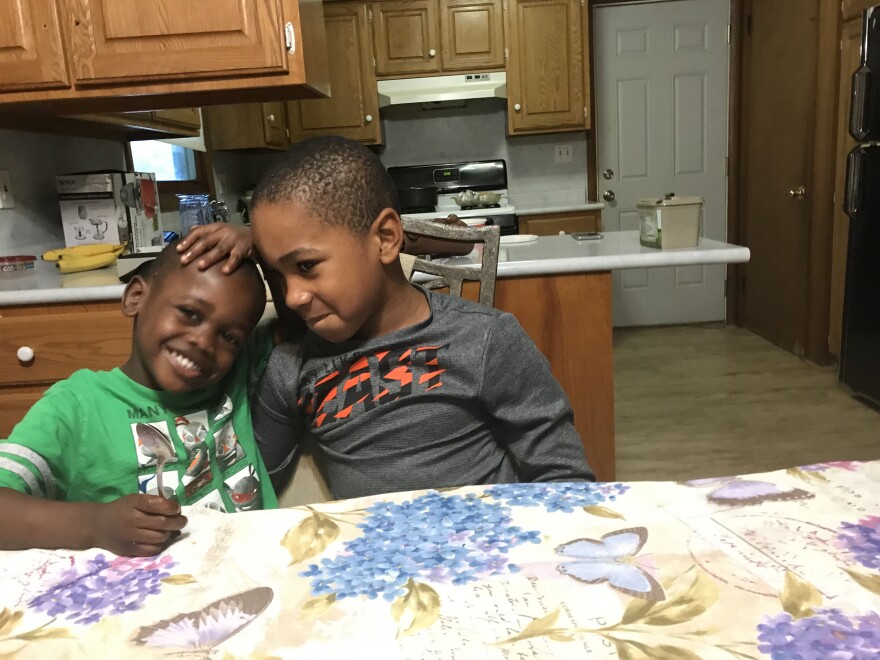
[507,0,587,134]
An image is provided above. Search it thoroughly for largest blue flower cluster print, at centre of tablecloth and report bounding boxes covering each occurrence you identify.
[300,492,540,601]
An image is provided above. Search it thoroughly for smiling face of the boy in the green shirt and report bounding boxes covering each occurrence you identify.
[122,265,265,392]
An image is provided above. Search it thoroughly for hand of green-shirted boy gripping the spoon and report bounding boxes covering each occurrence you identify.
[92,495,186,557]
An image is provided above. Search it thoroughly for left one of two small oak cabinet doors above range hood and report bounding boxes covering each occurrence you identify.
[372,0,440,76]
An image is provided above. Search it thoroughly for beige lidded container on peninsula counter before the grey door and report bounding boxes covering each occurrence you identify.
[636,196,703,249]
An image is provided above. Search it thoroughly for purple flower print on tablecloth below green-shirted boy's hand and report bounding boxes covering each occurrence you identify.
[28,554,174,624]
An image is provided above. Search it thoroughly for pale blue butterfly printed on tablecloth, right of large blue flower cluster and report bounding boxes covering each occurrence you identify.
[556,527,666,602]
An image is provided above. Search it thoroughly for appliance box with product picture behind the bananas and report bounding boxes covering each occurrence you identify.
[55,171,163,254]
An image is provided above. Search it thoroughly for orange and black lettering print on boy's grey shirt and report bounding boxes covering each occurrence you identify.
[297,346,446,428]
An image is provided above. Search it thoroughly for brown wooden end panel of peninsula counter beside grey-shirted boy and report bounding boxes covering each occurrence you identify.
[464,271,615,481]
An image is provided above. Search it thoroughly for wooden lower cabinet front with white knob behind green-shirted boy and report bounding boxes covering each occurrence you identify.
[0,301,131,438]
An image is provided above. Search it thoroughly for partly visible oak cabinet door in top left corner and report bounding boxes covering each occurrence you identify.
[0,0,69,91]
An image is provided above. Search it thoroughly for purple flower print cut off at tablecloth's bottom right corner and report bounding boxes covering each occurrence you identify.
[758,609,880,660]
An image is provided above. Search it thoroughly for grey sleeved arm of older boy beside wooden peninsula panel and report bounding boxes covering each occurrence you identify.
[481,314,595,482]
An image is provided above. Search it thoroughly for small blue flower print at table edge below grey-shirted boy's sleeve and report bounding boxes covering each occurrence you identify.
[485,481,629,513]
